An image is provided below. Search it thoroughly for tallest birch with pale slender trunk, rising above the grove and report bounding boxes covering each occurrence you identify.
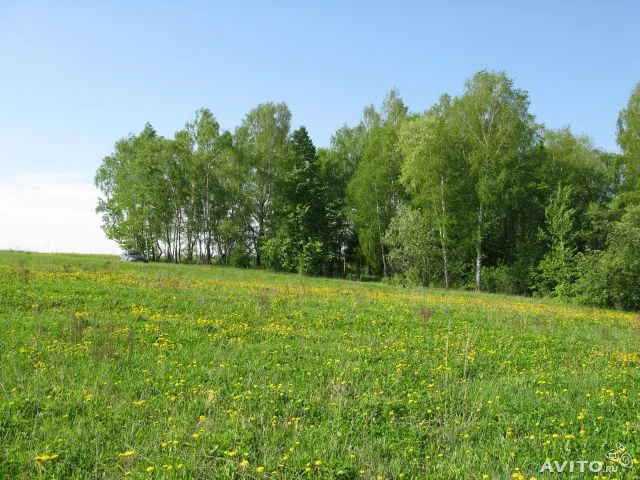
[453,71,540,290]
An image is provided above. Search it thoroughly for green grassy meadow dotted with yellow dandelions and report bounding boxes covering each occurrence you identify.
[0,252,640,479]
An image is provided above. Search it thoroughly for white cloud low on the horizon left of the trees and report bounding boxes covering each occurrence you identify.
[0,172,119,254]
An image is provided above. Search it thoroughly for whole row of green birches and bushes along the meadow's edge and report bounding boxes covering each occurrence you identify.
[95,71,640,309]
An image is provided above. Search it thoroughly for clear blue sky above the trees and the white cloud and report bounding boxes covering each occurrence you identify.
[0,0,640,253]
